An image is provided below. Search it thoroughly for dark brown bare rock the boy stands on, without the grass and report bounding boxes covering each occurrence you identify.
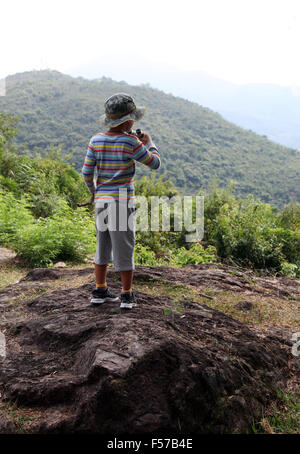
[0,267,298,434]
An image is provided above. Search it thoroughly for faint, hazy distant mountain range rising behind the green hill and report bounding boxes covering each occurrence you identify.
[67,55,300,149]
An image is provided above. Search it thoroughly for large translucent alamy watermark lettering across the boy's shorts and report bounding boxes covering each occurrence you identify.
[95,189,204,243]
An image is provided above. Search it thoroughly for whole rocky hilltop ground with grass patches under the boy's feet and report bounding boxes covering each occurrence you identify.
[0,263,300,436]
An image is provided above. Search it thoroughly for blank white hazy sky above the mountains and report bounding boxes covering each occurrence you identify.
[0,0,300,86]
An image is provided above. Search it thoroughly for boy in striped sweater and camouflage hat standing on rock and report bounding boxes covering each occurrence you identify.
[82,93,160,309]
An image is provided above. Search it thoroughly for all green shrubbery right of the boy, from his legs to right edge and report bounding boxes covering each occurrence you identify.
[132,177,300,277]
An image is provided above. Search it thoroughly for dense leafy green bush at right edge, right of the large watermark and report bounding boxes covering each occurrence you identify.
[200,180,300,276]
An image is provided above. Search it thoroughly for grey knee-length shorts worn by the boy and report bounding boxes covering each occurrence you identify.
[94,201,136,271]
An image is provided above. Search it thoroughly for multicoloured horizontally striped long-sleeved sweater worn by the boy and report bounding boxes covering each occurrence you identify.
[82,133,160,202]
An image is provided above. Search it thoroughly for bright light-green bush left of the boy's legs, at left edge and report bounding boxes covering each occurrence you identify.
[0,191,96,266]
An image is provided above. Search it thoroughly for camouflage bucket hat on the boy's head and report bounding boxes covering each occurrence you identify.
[99,93,146,128]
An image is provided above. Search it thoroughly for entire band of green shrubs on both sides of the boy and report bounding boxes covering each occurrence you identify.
[0,114,300,277]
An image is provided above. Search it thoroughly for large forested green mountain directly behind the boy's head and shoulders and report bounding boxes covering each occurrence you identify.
[0,70,300,207]
